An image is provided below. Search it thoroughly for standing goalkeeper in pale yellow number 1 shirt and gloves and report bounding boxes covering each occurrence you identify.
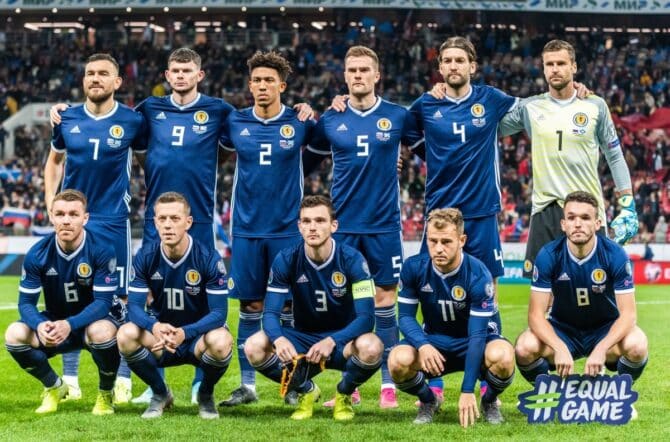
[499,40,638,278]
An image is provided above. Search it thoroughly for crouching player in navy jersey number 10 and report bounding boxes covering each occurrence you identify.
[117,192,233,419]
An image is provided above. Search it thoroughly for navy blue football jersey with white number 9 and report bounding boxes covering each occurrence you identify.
[137,94,233,225]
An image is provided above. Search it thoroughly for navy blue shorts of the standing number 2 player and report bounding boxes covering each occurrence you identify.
[228,235,302,301]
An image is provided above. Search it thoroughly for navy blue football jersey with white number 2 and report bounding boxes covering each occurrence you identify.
[222,105,315,238]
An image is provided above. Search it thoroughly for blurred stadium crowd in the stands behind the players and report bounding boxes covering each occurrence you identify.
[0,23,670,242]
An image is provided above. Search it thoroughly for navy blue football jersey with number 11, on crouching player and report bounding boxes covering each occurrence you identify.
[398,253,496,340]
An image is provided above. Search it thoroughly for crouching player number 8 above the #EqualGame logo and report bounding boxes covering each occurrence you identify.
[516,191,648,417]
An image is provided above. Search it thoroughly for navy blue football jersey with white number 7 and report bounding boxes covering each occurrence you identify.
[51,102,146,219]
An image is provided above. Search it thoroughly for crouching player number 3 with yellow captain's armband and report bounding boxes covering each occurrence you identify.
[244,196,384,420]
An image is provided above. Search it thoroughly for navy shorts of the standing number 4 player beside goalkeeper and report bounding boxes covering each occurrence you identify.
[421,215,505,279]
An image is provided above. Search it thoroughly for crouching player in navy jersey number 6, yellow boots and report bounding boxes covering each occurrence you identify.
[5,190,120,415]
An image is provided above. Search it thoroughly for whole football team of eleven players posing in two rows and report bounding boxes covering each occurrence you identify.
[5,37,647,427]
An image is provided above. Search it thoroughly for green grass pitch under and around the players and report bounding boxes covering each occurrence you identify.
[0,276,670,442]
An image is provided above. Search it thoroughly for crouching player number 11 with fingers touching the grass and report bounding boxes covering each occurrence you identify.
[389,209,514,427]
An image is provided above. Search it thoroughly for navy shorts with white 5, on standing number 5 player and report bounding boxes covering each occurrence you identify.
[333,232,403,286]
